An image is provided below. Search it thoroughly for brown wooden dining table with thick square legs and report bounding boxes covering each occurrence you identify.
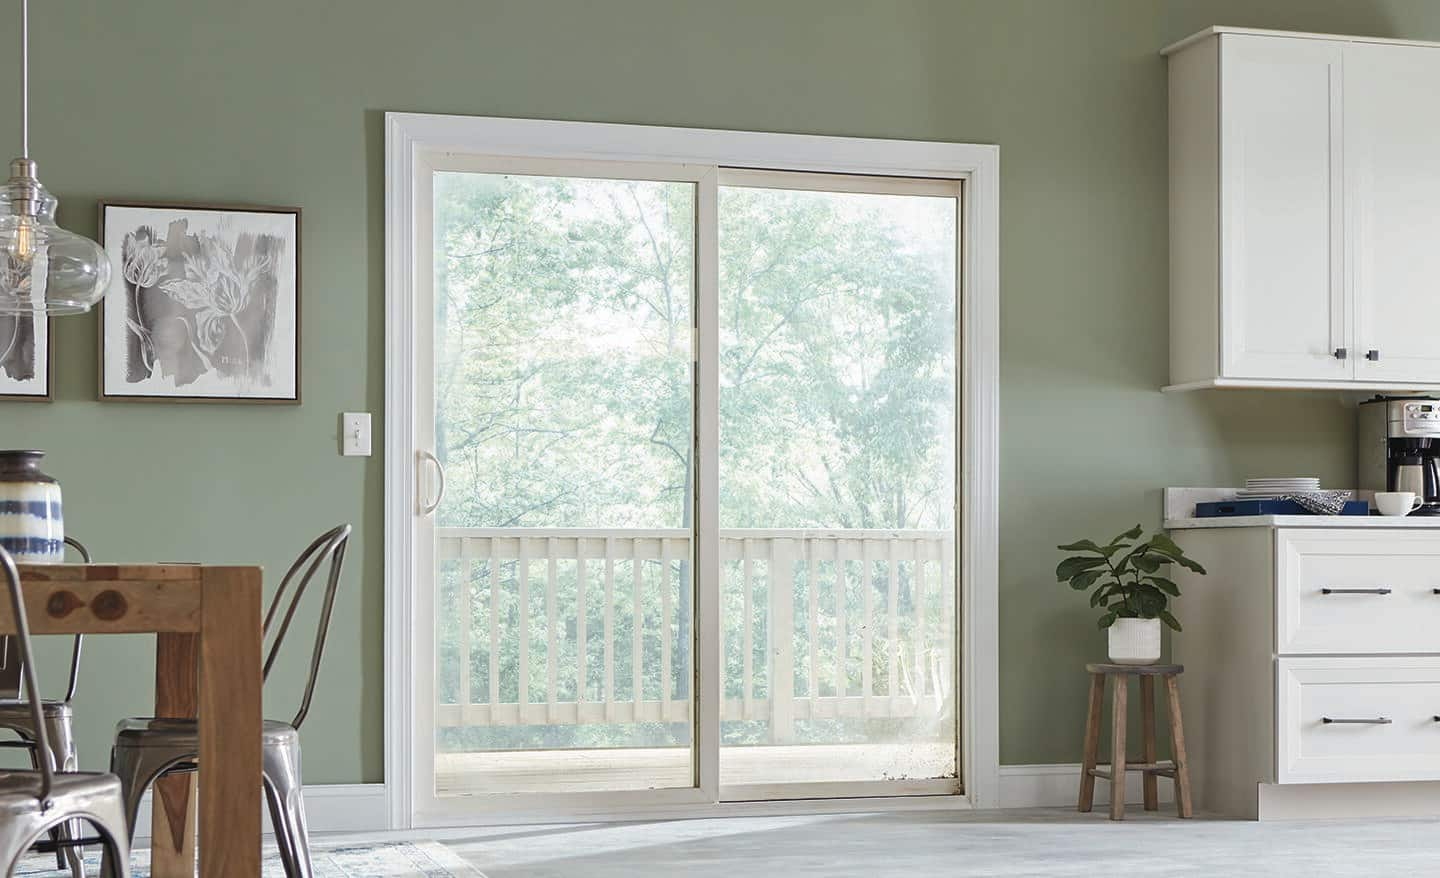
[12,563,262,878]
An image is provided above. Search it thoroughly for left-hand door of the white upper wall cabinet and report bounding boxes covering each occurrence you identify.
[1220,35,1354,380]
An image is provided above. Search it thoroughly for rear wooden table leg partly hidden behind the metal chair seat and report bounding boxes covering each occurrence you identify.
[150,633,200,878]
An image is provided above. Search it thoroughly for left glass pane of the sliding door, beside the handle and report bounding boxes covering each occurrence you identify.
[433,173,696,796]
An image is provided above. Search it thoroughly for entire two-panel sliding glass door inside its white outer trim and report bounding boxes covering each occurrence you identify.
[415,154,962,813]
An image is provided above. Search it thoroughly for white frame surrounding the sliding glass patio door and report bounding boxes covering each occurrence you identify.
[384,112,999,829]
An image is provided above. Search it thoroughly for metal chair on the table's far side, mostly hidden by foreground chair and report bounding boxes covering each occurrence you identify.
[0,537,91,878]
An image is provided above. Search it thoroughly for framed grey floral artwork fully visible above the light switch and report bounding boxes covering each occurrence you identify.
[99,202,300,404]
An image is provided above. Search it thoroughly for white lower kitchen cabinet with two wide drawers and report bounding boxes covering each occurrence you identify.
[1171,522,1440,819]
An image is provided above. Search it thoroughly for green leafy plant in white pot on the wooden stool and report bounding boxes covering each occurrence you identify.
[1056,524,1205,665]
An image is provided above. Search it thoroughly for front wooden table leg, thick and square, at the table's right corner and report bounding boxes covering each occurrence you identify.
[200,567,261,878]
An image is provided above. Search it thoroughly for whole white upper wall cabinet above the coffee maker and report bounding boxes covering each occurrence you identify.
[1166,29,1440,389]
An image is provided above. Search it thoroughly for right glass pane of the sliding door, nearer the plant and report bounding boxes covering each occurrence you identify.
[720,179,959,784]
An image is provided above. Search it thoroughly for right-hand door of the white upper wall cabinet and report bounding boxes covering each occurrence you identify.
[1345,43,1440,383]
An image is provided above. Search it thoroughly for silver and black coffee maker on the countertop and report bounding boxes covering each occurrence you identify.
[1356,396,1440,515]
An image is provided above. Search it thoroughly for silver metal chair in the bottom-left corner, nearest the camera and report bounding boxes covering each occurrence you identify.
[0,548,130,878]
